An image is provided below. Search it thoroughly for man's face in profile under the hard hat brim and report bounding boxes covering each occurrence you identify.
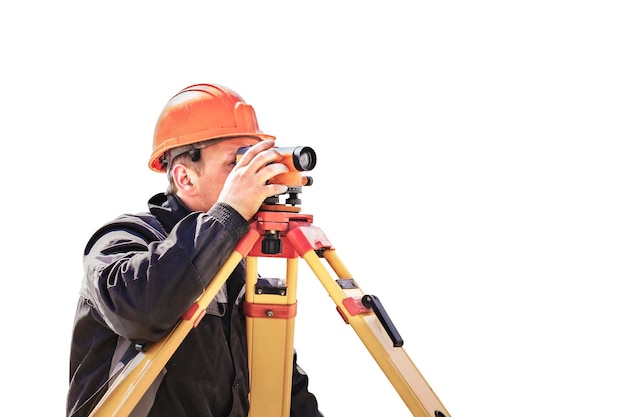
[194,137,258,211]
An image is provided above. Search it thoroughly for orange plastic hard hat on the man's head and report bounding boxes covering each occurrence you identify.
[148,84,275,172]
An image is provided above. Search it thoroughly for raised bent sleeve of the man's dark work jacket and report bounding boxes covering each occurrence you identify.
[82,203,249,342]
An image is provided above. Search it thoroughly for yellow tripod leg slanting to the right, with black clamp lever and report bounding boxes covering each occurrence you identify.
[302,249,450,417]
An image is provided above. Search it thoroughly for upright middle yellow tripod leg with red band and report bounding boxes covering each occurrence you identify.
[244,256,298,417]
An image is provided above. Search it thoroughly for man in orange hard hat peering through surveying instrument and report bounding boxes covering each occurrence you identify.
[67,84,321,417]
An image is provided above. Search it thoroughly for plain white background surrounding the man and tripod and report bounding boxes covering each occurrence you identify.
[0,0,626,417]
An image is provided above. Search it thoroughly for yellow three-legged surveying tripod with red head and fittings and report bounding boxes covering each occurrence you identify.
[89,148,450,417]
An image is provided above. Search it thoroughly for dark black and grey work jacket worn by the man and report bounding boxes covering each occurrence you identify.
[67,194,321,417]
